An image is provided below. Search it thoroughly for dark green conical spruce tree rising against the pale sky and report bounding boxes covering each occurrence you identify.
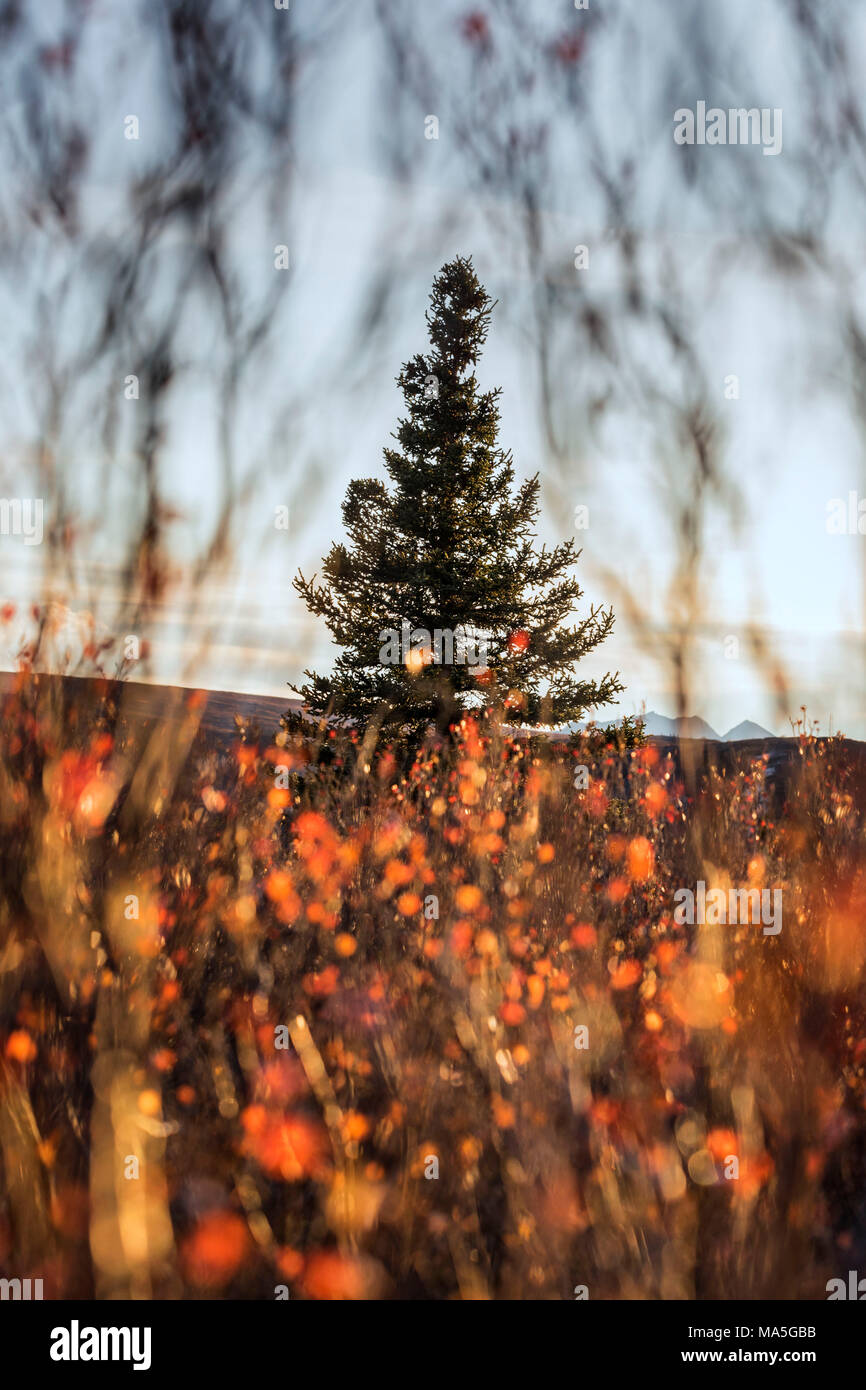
[295,257,623,734]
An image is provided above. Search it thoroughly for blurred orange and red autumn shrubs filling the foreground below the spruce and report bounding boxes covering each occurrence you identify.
[0,681,866,1300]
